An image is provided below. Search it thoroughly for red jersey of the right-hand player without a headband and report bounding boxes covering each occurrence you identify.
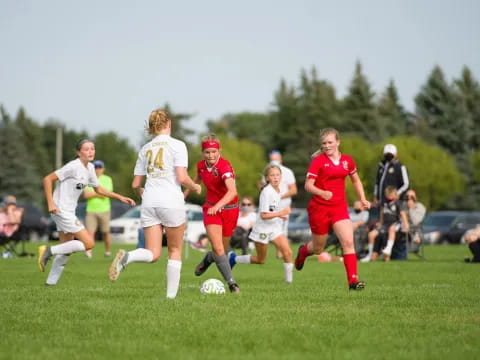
[307,153,357,205]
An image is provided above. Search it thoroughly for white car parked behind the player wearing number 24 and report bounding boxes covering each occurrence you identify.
[110,203,206,244]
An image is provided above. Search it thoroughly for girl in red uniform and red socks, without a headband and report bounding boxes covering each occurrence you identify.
[295,128,370,290]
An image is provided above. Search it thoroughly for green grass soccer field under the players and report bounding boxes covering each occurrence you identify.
[0,244,480,359]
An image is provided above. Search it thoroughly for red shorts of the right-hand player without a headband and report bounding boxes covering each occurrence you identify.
[307,201,350,235]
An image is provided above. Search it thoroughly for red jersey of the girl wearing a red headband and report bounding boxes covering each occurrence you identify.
[197,156,238,205]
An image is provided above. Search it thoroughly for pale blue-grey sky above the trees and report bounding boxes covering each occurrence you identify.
[0,0,480,147]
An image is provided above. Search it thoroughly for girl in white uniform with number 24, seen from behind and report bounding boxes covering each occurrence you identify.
[109,110,202,298]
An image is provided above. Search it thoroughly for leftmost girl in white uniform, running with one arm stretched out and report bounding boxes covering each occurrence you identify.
[38,139,135,285]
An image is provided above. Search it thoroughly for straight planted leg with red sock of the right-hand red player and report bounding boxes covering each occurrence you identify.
[333,219,365,290]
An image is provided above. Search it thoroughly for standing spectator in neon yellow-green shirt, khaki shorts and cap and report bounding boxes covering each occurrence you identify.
[83,160,113,257]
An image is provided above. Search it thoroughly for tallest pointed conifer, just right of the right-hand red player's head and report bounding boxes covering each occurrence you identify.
[340,62,381,141]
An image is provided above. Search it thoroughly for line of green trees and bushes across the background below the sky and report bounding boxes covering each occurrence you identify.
[0,62,480,210]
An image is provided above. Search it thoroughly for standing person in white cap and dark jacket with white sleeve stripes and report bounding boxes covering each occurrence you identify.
[373,144,410,206]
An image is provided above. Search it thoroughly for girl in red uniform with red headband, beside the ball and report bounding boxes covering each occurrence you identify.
[188,134,240,293]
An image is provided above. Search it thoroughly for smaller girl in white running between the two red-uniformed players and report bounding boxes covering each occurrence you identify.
[229,165,293,283]
